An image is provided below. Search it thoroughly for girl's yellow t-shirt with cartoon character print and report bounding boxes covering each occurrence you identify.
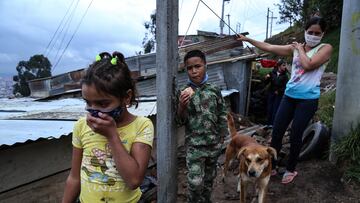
[72,116,154,203]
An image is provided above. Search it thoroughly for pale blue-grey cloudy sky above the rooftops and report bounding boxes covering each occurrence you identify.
[0,0,288,76]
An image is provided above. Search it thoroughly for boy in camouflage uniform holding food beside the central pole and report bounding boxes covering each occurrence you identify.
[176,50,228,203]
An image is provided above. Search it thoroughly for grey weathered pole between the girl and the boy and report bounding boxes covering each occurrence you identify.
[156,0,179,203]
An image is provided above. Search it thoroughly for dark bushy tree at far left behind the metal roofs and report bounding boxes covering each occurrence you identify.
[13,55,51,96]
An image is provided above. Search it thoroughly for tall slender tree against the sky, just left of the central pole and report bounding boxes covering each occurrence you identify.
[142,11,156,54]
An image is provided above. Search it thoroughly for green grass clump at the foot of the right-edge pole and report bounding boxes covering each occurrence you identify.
[331,123,360,182]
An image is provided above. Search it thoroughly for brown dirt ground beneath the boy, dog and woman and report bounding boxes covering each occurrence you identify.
[177,155,360,203]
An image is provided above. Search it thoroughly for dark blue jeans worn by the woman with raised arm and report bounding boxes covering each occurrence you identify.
[270,95,319,172]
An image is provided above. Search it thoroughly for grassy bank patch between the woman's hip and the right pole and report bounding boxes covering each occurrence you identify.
[315,90,336,129]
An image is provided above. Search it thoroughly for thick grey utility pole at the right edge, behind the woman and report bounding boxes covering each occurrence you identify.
[330,0,360,162]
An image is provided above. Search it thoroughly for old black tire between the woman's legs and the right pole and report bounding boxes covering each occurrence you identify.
[299,122,330,160]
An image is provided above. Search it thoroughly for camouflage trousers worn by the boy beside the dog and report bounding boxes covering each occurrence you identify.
[186,145,221,203]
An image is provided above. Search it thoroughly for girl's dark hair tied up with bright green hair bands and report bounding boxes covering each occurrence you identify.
[81,52,138,107]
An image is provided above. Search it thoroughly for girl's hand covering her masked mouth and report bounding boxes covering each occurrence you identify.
[86,112,117,138]
